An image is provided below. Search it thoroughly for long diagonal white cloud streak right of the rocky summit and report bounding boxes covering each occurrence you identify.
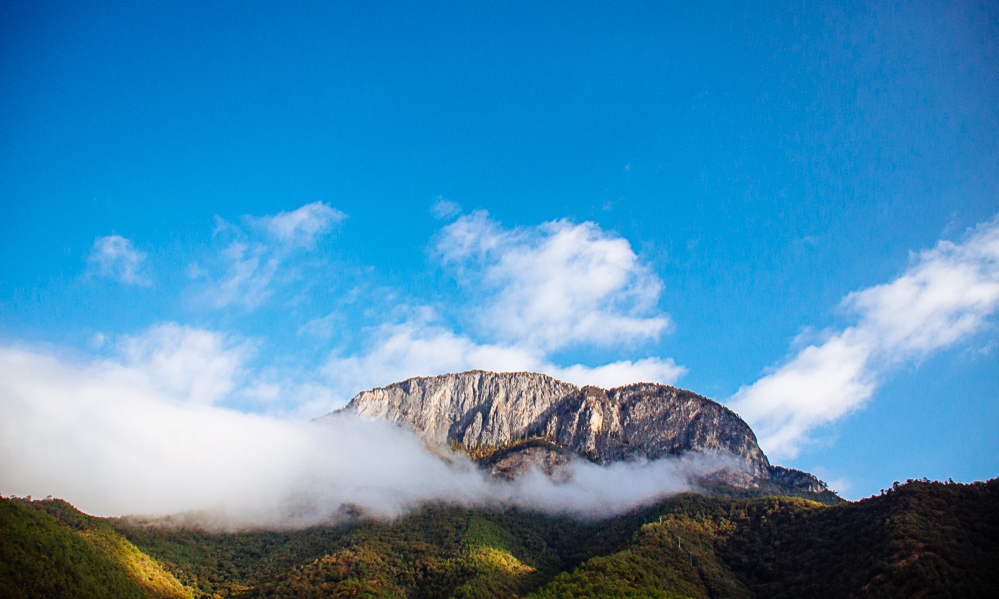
[728,218,999,457]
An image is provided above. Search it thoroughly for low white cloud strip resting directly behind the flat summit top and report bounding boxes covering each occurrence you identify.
[322,308,686,400]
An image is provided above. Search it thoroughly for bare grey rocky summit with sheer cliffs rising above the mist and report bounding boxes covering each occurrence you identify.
[319,370,829,494]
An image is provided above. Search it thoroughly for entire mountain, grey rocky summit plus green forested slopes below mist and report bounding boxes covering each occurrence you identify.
[0,371,999,599]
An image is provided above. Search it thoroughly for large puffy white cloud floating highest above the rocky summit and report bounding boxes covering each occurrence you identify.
[437,211,670,351]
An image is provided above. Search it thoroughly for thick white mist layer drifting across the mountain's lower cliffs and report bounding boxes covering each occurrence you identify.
[0,348,736,527]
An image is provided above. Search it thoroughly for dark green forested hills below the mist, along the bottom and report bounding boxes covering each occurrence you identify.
[0,479,999,599]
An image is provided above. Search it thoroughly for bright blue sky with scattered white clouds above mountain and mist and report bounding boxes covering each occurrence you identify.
[0,2,999,498]
